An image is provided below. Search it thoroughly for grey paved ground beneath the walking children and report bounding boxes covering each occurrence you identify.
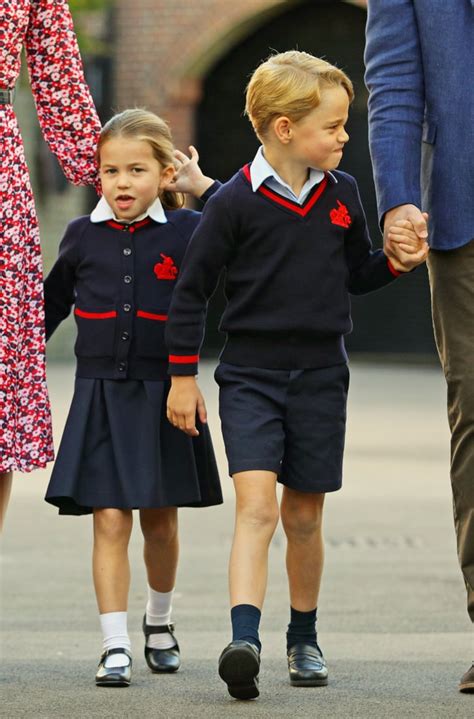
[0,363,474,719]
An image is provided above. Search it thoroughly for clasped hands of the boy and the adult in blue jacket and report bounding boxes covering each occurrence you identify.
[384,210,429,272]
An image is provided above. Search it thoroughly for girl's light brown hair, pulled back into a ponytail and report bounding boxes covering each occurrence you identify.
[97,108,184,210]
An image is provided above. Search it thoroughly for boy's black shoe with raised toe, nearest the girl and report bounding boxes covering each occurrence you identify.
[219,639,260,699]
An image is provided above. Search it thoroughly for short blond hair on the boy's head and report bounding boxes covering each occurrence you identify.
[245,50,354,140]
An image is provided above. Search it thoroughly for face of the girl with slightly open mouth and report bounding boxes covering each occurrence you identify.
[100,137,175,221]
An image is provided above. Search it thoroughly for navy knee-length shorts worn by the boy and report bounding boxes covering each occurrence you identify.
[214,362,349,493]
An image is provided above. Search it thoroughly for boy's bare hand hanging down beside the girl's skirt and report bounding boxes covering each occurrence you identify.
[166,376,207,437]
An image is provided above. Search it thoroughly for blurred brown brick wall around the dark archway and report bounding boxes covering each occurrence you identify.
[114,0,366,148]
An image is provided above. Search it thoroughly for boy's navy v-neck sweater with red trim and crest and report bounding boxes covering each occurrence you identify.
[165,165,399,375]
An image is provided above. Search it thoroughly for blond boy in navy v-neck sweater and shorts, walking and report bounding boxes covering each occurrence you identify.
[166,51,427,699]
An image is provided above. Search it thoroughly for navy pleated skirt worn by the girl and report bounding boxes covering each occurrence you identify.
[45,377,222,514]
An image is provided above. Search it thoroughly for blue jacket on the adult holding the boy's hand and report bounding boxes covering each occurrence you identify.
[365,0,474,250]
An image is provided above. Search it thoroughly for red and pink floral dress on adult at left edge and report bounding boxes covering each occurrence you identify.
[0,0,100,472]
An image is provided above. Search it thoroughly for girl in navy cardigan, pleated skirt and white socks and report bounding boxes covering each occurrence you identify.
[45,110,222,686]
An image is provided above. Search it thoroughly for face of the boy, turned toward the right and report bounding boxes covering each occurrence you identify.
[288,86,349,170]
